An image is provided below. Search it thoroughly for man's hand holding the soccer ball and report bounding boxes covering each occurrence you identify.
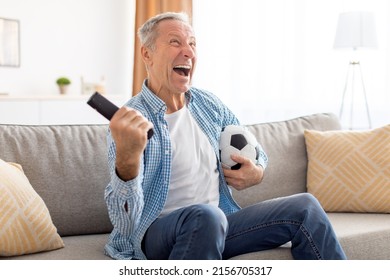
[223,155,264,191]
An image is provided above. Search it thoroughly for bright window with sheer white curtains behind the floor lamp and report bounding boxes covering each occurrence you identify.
[193,0,390,126]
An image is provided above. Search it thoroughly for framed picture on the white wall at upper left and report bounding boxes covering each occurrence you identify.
[0,18,20,67]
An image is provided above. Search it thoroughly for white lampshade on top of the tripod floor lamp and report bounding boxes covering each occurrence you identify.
[334,12,378,50]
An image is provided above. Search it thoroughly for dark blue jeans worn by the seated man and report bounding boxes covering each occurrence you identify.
[144,193,346,260]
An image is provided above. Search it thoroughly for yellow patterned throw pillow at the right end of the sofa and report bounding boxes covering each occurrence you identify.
[304,125,390,213]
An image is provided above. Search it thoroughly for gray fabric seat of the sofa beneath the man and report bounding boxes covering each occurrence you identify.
[7,213,390,260]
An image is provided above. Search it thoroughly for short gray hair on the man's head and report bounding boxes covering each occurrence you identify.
[138,12,191,49]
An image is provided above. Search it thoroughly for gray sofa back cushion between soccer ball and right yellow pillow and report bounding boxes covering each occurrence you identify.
[233,113,340,207]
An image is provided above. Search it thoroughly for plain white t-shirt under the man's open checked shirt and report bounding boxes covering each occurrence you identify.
[160,106,219,216]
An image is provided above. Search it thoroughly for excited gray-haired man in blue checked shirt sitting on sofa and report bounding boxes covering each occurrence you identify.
[105,13,345,259]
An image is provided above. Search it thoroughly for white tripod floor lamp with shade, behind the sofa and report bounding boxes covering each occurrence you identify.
[334,12,378,129]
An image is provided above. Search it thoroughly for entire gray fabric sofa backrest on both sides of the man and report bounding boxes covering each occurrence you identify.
[0,114,340,236]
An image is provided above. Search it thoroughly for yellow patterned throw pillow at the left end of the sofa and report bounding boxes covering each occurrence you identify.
[0,159,64,256]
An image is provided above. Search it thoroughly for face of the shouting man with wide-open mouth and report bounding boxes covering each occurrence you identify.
[144,20,196,95]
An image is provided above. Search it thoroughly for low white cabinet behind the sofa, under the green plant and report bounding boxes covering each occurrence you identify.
[0,95,129,125]
